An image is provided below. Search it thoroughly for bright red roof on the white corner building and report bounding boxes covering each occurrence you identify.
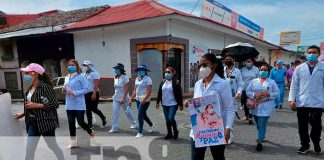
[64,0,193,30]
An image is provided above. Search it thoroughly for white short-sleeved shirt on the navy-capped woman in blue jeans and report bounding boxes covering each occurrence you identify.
[135,76,152,101]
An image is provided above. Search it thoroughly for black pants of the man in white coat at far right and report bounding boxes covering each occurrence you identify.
[297,107,322,146]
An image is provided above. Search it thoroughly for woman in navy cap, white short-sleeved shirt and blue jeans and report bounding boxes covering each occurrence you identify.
[129,64,155,138]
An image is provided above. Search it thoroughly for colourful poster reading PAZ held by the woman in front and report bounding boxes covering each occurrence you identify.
[189,95,226,148]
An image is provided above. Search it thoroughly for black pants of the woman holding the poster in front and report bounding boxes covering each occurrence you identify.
[191,138,226,160]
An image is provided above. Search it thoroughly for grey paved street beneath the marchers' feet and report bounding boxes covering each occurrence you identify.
[4,93,324,160]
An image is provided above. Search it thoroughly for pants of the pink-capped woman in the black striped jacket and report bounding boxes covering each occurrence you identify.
[25,118,64,160]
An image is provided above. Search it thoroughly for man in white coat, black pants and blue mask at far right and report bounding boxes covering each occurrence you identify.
[289,45,324,154]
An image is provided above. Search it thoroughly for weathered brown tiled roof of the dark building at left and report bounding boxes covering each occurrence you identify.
[0,6,109,34]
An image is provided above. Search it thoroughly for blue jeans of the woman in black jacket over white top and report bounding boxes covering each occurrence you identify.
[162,105,178,135]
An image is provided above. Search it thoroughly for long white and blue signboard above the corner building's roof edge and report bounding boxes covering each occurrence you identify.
[201,0,264,40]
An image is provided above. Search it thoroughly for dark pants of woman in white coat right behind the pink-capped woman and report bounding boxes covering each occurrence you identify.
[66,110,92,138]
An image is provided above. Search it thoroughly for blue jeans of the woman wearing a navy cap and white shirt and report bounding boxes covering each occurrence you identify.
[136,100,153,134]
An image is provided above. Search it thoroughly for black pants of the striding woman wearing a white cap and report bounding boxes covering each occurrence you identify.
[84,92,105,126]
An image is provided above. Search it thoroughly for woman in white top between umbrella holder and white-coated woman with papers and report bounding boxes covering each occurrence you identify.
[241,58,259,124]
